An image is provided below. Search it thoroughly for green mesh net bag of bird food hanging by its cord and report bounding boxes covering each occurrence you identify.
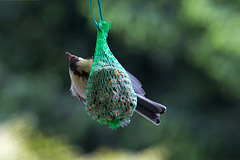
[85,0,137,128]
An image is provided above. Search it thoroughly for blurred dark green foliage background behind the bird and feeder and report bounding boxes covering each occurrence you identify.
[0,0,240,160]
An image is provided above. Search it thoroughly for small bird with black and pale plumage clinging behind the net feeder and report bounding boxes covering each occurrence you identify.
[66,52,167,127]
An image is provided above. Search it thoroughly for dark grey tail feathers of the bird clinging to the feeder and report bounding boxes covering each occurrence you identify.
[135,94,166,125]
